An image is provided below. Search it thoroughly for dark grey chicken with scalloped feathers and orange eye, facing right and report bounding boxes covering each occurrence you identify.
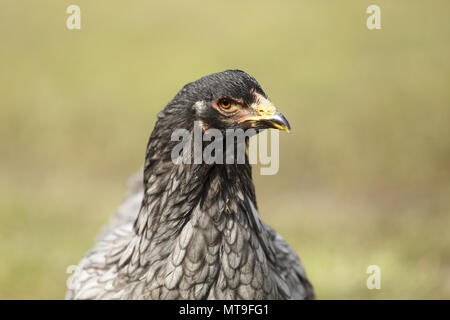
[66,70,314,299]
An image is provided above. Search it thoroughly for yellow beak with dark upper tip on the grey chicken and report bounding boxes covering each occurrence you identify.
[239,103,291,132]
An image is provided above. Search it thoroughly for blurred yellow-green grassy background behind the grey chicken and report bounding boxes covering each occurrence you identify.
[0,0,450,299]
